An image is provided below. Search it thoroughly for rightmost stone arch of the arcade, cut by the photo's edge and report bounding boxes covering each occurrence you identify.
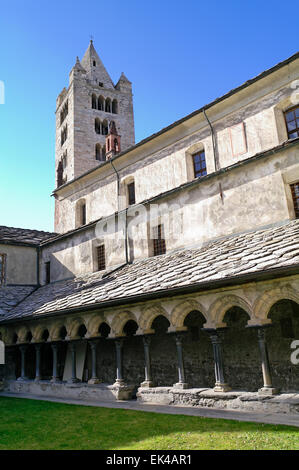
[253,286,299,324]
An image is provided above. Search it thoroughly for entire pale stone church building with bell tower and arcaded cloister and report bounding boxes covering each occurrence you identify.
[0,41,299,412]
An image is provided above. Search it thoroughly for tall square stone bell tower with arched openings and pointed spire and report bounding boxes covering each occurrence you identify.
[55,41,135,187]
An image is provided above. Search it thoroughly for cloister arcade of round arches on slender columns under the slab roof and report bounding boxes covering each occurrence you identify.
[0,283,299,394]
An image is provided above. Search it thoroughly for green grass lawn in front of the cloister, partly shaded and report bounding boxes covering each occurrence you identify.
[0,397,299,450]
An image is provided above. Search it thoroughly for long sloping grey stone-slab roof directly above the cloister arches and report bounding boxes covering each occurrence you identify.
[5,219,299,320]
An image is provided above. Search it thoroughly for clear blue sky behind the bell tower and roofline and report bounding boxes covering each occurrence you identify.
[0,0,298,230]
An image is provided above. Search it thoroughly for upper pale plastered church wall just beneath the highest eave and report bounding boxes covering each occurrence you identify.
[54,57,298,232]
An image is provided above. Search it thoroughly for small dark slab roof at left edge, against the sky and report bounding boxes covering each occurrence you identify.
[0,225,57,245]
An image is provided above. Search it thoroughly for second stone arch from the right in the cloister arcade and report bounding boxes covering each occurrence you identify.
[209,295,253,328]
